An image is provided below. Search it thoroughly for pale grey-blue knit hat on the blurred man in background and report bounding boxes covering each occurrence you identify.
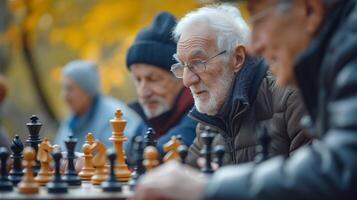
[63,60,99,97]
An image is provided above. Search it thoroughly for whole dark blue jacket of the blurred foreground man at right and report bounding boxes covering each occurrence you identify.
[205,0,357,200]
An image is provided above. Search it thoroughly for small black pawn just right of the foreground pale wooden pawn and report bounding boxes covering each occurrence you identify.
[46,149,68,193]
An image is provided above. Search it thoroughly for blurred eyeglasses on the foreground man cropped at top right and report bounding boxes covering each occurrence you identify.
[248,1,292,24]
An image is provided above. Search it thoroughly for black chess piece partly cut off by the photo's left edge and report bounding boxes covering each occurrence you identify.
[0,147,12,191]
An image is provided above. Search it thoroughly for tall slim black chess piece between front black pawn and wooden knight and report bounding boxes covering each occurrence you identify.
[63,134,82,186]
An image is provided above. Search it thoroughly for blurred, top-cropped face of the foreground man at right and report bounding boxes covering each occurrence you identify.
[248,0,322,85]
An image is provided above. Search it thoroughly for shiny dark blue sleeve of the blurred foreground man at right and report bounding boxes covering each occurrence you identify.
[204,62,357,200]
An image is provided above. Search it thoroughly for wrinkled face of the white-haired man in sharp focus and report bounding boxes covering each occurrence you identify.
[177,23,235,115]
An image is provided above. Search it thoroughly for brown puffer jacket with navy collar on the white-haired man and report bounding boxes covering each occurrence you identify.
[187,57,310,167]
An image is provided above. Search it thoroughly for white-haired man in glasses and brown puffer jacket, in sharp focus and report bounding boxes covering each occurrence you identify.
[171,5,310,166]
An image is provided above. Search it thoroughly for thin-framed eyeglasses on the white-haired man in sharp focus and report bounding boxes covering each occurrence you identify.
[170,50,227,78]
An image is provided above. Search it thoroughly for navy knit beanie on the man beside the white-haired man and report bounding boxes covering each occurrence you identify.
[126,12,176,71]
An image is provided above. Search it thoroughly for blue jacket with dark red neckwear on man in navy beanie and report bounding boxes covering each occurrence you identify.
[124,88,197,156]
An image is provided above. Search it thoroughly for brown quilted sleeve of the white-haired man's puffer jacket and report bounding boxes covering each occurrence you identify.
[284,89,311,154]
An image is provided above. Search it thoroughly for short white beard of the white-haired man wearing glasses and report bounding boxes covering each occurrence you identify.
[190,66,235,116]
